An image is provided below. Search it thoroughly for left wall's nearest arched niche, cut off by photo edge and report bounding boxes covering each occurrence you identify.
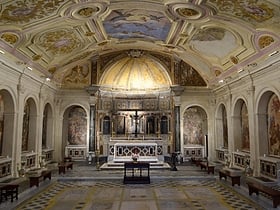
[0,89,15,157]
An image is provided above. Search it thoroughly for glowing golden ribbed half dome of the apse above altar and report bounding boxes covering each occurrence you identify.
[99,54,171,94]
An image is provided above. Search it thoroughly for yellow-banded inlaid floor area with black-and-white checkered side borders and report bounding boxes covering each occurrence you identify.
[16,179,261,210]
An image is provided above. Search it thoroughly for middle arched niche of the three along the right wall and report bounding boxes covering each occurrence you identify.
[233,99,250,152]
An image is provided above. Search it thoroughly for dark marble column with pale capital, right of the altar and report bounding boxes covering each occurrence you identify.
[171,85,184,152]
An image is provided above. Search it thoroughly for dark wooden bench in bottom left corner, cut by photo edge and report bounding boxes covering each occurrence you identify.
[0,183,19,203]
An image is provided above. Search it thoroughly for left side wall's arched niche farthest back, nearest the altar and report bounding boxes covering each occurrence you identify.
[42,103,53,149]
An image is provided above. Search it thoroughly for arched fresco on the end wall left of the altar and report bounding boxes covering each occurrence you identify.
[68,107,87,145]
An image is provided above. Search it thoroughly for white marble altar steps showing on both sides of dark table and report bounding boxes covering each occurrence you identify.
[100,161,171,170]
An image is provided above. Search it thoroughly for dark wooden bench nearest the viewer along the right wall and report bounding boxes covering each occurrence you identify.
[247,181,280,208]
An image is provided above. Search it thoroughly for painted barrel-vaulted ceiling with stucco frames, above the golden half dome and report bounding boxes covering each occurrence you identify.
[0,0,280,88]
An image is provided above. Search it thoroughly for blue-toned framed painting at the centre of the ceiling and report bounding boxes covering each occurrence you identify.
[104,9,171,41]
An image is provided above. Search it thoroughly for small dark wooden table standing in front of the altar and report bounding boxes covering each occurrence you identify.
[123,162,150,184]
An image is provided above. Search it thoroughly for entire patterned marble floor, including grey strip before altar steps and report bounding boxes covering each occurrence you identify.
[0,163,280,210]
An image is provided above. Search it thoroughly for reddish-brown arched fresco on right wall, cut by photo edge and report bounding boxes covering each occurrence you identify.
[268,94,280,156]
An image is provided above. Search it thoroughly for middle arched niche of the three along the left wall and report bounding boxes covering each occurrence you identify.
[21,98,37,152]
